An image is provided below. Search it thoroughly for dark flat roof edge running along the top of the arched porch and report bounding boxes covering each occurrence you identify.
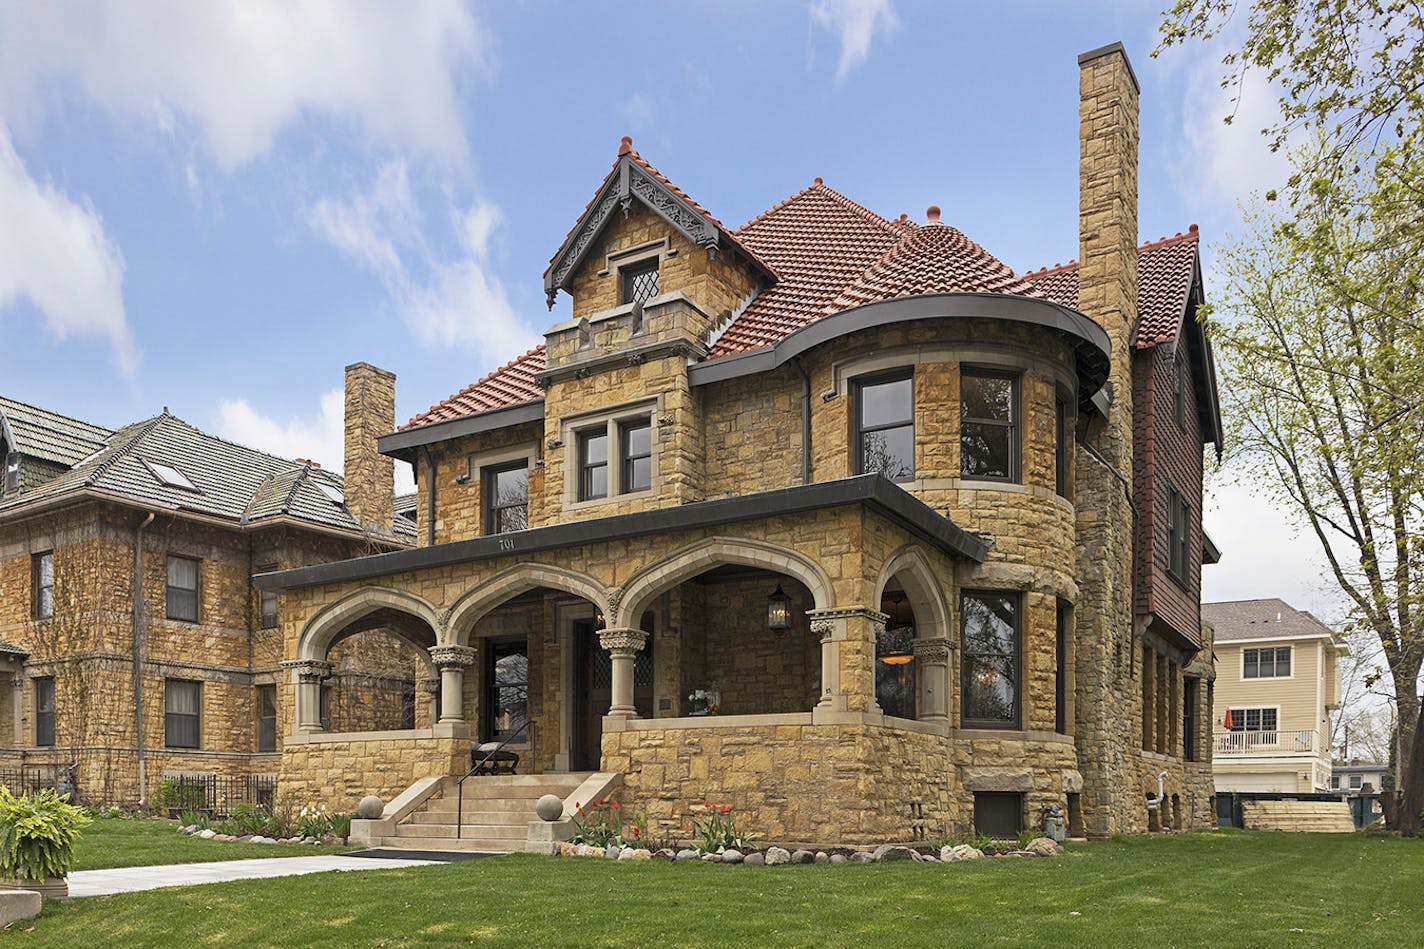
[253,475,988,590]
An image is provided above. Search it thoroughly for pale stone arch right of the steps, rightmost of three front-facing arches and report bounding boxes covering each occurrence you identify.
[609,537,836,628]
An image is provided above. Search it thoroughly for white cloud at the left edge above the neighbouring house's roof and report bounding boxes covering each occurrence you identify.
[0,121,138,376]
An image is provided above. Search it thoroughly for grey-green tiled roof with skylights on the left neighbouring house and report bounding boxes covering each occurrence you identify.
[0,403,414,534]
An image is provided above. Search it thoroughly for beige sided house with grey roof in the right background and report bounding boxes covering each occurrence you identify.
[1202,598,1349,794]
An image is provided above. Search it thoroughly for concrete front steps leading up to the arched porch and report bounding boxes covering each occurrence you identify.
[370,772,594,854]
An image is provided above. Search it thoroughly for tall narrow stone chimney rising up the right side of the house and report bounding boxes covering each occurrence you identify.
[1074,43,1145,836]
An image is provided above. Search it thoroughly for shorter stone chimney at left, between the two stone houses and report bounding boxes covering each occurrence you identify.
[346,362,396,533]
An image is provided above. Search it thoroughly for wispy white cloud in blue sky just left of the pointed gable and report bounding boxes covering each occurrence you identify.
[309,161,535,356]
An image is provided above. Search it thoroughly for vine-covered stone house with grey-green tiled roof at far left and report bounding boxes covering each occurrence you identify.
[0,365,415,804]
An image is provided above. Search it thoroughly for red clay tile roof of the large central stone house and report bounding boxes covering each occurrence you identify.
[402,140,1198,429]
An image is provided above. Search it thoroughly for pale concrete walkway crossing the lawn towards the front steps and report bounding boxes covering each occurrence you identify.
[70,855,437,899]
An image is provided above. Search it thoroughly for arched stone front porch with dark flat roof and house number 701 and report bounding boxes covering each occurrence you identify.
[262,476,984,839]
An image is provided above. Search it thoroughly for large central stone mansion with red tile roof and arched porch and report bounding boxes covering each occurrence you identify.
[258,46,1220,845]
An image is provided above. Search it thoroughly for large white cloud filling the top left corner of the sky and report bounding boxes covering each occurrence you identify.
[0,0,490,171]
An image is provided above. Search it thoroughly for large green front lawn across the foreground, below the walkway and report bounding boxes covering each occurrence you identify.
[19,831,1424,949]
